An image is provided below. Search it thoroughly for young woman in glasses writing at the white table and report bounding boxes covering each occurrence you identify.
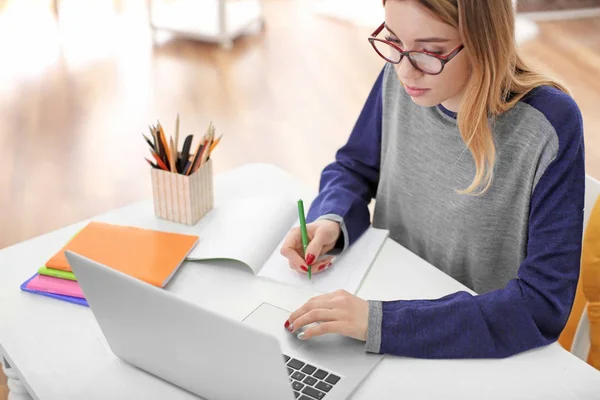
[281,0,585,358]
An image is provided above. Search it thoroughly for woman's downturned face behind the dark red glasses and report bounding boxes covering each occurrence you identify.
[378,0,471,111]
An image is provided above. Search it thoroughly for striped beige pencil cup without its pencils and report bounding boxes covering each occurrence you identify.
[152,159,214,225]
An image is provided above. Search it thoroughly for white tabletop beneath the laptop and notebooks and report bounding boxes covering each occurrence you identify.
[0,165,600,400]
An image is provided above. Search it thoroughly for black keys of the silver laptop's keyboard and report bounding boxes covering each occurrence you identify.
[283,354,340,400]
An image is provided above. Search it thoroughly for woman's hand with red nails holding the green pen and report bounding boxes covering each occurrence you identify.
[281,219,341,274]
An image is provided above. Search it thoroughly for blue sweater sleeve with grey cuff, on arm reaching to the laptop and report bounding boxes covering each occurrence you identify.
[365,89,585,358]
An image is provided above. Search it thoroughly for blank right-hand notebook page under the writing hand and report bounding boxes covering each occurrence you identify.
[258,228,389,294]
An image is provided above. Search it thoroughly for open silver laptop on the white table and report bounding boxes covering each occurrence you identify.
[65,251,382,400]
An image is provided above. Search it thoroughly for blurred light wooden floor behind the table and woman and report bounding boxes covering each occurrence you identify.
[0,0,600,399]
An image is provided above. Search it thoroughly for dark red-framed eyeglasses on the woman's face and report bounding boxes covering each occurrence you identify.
[369,22,465,75]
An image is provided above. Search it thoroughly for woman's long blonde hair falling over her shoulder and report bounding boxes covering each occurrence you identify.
[383,0,568,195]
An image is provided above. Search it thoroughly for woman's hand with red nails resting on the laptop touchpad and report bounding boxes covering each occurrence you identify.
[285,290,369,341]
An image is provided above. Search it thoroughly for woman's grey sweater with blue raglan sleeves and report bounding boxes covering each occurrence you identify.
[307,65,585,358]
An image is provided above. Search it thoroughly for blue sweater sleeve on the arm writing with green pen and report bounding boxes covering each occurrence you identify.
[306,70,384,249]
